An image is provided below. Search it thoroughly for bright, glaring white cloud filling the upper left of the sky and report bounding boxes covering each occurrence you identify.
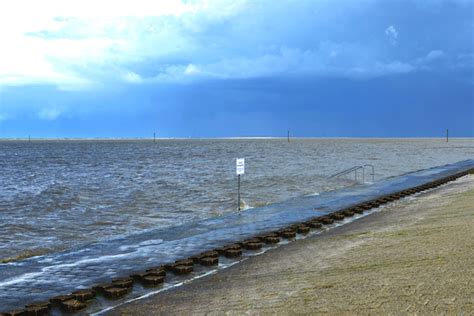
[0,0,250,89]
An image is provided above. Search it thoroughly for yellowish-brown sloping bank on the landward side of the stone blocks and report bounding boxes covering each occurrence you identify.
[111,175,474,315]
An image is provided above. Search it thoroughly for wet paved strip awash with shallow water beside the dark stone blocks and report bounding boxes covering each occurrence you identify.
[0,160,474,309]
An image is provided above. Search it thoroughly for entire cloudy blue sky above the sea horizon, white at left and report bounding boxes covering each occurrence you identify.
[0,0,474,138]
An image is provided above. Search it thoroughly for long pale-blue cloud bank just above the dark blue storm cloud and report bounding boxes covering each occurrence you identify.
[112,42,430,84]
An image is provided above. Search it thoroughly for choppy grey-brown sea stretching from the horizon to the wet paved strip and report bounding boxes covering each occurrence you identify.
[0,139,474,260]
